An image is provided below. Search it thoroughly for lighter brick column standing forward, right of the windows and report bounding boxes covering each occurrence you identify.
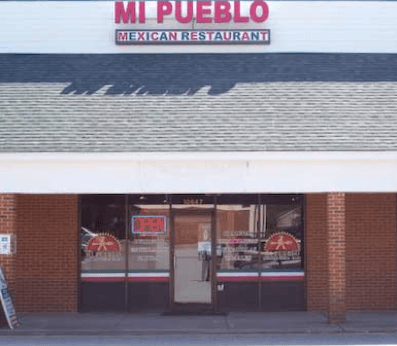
[327,192,346,323]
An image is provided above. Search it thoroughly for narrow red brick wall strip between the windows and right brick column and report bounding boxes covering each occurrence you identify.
[305,194,328,311]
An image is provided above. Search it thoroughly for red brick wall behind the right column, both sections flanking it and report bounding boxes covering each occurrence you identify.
[305,193,397,311]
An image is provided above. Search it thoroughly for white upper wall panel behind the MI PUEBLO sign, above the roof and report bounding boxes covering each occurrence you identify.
[0,1,397,54]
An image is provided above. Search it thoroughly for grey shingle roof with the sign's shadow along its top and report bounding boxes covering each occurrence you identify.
[0,54,397,153]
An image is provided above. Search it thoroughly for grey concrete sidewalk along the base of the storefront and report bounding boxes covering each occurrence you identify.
[0,312,397,336]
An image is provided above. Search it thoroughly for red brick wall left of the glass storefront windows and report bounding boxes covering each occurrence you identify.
[3,195,78,312]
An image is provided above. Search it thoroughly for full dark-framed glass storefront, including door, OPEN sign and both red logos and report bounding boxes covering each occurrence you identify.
[81,194,304,310]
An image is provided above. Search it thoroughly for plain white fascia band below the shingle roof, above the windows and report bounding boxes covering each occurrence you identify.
[0,152,397,193]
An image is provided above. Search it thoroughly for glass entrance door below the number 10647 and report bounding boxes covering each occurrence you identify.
[174,210,212,304]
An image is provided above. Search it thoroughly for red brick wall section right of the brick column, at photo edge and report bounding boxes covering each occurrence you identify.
[346,194,397,310]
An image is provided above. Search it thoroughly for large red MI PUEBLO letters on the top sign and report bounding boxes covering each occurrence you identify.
[114,0,269,24]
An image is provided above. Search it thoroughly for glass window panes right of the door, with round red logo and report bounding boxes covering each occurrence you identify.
[217,204,303,271]
